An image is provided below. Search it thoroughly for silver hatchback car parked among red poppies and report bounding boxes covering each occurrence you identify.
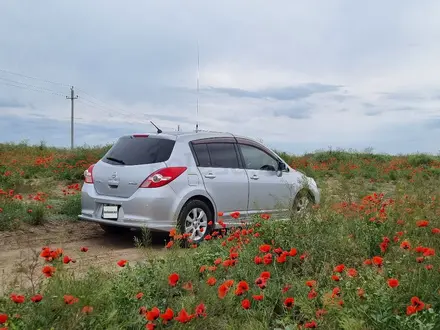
[79,132,320,242]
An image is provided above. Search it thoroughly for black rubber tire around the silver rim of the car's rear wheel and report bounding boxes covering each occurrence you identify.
[177,199,214,247]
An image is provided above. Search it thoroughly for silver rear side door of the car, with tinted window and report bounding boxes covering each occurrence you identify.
[192,139,249,224]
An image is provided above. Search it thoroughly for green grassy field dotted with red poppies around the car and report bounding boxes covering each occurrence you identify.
[0,145,440,330]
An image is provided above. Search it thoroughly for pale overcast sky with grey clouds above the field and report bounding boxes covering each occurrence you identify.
[0,0,440,153]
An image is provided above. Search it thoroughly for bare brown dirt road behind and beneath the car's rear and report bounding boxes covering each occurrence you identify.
[0,221,168,295]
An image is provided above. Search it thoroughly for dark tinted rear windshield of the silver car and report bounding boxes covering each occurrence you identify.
[102,136,175,165]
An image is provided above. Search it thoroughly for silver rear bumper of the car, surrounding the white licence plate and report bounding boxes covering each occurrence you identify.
[78,184,177,231]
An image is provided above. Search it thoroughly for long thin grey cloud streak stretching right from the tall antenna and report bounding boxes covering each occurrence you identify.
[205,83,341,101]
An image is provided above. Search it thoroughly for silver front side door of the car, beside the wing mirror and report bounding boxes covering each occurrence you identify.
[238,142,295,216]
